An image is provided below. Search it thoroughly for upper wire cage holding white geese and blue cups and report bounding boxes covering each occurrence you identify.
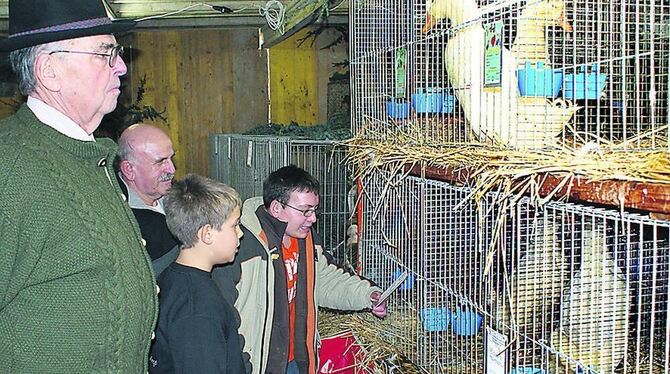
[350,0,670,149]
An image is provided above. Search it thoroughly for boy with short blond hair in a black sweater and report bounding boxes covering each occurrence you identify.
[149,174,245,374]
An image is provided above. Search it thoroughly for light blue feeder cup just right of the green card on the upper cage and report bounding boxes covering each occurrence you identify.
[516,61,563,97]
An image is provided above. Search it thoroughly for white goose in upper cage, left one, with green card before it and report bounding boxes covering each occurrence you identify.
[423,0,578,148]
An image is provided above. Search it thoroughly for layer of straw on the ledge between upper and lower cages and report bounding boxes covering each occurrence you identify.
[343,123,670,209]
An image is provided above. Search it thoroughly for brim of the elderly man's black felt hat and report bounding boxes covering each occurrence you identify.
[0,20,137,52]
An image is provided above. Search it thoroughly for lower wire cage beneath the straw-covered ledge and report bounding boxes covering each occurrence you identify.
[360,172,670,374]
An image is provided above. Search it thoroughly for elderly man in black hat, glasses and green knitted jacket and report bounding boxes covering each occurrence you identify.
[0,0,157,373]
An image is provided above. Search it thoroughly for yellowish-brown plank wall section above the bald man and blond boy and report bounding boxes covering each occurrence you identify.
[126,29,268,177]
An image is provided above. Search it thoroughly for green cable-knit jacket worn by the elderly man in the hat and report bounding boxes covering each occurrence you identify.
[0,105,158,373]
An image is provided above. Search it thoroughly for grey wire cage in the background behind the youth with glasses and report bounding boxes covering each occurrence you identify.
[210,134,356,267]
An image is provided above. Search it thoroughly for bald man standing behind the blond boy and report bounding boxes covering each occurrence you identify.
[117,124,179,276]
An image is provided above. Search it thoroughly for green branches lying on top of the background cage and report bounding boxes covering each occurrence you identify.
[245,115,351,140]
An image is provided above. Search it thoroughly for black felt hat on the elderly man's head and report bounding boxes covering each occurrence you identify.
[0,0,136,52]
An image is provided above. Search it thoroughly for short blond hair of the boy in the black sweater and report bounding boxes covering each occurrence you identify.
[163,174,242,248]
